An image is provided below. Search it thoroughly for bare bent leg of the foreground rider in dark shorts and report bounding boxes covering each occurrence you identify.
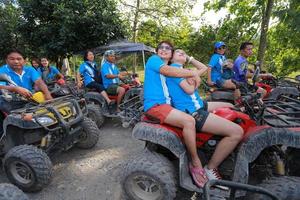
[202,113,243,169]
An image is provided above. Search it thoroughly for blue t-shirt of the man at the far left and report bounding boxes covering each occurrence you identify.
[0,65,41,92]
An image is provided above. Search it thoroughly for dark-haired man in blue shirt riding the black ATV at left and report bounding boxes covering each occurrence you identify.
[0,49,52,113]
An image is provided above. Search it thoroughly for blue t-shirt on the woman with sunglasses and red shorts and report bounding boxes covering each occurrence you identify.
[144,55,171,111]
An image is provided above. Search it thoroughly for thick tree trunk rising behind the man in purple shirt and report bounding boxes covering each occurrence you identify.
[257,0,274,67]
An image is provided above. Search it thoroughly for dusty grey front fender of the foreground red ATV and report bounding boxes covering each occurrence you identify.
[233,128,300,183]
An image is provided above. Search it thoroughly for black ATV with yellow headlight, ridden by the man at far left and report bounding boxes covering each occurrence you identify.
[0,74,99,192]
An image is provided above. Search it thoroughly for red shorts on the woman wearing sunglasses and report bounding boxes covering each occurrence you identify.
[145,104,174,124]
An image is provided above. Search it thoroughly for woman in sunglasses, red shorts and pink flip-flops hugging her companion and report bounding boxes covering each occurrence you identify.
[144,41,207,187]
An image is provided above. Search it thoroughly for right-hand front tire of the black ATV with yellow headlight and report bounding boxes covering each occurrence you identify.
[76,117,99,149]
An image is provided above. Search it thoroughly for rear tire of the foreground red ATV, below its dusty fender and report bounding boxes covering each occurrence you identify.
[122,151,177,200]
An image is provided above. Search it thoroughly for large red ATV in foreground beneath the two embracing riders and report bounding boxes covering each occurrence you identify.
[122,95,300,200]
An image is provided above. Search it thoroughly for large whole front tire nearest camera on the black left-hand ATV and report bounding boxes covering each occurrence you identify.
[3,145,52,192]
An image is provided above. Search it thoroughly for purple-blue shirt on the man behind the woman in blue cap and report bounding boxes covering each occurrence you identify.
[233,55,248,83]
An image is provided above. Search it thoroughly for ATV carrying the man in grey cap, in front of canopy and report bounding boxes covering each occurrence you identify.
[84,73,143,128]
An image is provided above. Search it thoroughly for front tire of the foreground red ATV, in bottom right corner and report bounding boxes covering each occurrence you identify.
[246,176,300,200]
